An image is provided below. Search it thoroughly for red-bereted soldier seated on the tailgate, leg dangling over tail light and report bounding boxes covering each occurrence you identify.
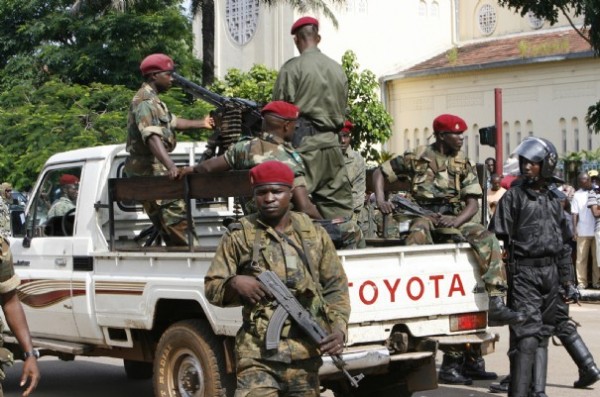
[373,114,525,384]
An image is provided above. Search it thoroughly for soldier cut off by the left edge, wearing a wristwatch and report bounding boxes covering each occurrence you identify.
[0,221,40,397]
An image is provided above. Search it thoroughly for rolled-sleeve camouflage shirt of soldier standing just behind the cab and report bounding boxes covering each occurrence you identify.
[125,83,177,175]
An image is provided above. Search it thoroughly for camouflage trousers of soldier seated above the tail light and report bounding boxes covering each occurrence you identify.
[406,217,507,296]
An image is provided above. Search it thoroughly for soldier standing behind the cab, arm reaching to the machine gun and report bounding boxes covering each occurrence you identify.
[125,54,213,246]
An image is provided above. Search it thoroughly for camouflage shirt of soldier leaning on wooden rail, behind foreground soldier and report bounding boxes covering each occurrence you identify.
[224,132,306,187]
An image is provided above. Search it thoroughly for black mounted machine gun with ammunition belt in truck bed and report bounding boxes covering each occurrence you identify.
[171,73,262,158]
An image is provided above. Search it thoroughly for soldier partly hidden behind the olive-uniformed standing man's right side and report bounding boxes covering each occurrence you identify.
[339,120,369,248]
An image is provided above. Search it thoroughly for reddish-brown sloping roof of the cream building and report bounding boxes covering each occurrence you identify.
[395,28,593,77]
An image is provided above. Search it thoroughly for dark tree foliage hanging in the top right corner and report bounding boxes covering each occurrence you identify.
[498,0,600,134]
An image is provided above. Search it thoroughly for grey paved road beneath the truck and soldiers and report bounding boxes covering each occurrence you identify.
[4,303,600,397]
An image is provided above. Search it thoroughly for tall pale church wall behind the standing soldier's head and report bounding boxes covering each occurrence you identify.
[194,0,454,77]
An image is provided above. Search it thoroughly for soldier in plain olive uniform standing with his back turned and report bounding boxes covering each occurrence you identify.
[273,17,352,223]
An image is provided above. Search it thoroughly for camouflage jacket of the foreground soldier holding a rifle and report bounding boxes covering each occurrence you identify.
[204,212,350,363]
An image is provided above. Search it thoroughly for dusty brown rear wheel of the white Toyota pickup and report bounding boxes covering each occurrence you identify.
[153,320,235,397]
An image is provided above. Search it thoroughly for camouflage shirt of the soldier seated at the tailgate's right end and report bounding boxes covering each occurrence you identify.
[381,145,483,204]
